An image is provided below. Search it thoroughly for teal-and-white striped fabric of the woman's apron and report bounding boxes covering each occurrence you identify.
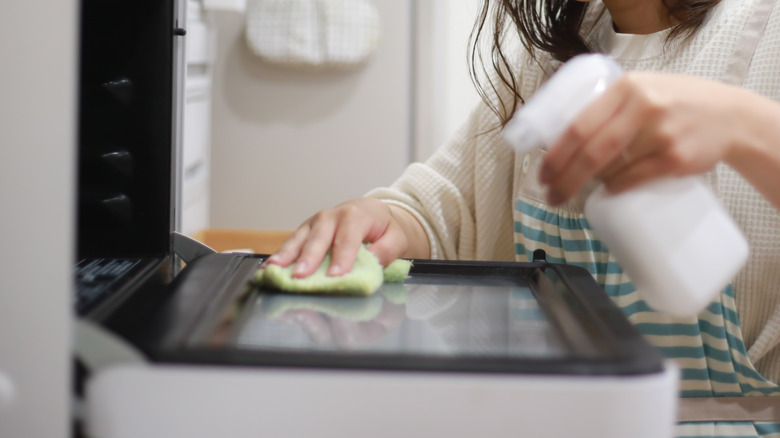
[514,198,780,438]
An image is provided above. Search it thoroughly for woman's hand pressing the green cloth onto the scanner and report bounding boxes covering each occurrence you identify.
[268,198,430,278]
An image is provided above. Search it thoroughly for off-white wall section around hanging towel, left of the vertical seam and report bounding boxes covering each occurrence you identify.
[210,0,412,229]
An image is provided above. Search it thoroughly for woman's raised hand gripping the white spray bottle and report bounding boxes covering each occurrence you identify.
[540,72,757,205]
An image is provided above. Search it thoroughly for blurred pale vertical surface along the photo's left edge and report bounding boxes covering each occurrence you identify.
[0,0,78,438]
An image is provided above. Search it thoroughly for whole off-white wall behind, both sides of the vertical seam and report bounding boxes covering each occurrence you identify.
[210,0,479,229]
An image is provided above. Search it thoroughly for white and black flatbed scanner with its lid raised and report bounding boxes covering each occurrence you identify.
[74,0,678,438]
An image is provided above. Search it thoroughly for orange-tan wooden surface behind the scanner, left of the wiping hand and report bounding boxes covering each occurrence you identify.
[192,229,292,254]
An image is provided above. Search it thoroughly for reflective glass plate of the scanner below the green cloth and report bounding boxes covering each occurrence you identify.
[234,276,567,358]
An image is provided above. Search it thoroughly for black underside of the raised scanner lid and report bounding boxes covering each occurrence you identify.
[77,0,174,259]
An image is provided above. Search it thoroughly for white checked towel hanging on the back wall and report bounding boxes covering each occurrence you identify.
[246,0,379,67]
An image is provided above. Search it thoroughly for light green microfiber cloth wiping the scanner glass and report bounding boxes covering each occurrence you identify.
[255,246,412,296]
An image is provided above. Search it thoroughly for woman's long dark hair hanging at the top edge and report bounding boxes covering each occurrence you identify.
[469,0,720,126]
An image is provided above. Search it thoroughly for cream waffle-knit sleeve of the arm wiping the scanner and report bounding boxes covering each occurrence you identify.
[367,99,514,260]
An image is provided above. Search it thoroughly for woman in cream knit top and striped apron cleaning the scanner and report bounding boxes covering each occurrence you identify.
[269,0,780,436]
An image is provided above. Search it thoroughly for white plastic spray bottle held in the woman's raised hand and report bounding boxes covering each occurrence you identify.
[503,55,748,317]
